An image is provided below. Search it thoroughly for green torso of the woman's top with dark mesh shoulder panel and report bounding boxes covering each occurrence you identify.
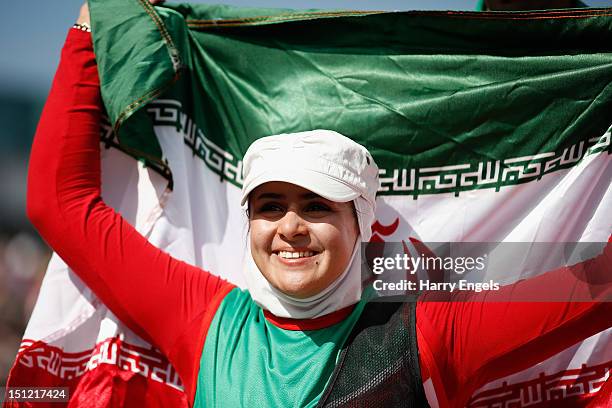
[194,288,424,408]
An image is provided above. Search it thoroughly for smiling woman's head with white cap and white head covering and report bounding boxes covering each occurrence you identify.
[242,130,379,318]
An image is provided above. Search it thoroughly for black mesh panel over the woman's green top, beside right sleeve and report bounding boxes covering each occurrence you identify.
[317,302,429,408]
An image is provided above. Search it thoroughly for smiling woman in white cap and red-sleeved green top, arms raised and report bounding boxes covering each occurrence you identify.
[10,1,612,408]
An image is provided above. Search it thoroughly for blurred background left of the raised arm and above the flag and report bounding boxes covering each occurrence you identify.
[0,0,612,388]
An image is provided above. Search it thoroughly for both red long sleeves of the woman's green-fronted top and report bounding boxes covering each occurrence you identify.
[27,30,612,407]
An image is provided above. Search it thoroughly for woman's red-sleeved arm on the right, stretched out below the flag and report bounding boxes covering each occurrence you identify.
[417,243,612,406]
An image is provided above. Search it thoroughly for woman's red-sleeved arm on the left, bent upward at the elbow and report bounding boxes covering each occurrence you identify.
[27,19,232,394]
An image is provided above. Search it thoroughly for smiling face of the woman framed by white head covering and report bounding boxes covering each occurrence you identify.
[249,182,359,298]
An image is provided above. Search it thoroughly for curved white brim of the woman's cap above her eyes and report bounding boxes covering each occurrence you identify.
[240,169,360,206]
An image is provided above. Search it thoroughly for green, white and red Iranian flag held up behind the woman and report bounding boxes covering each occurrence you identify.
[4,0,612,408]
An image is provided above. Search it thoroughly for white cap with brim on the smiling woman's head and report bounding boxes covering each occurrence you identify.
[241,129,379,207]
